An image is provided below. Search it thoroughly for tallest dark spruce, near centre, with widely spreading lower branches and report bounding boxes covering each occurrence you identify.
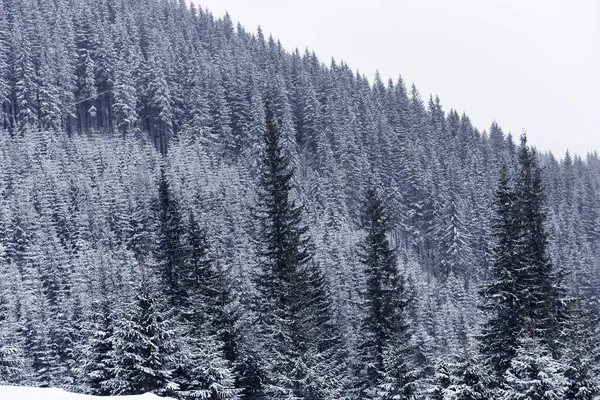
[254,104,344,400]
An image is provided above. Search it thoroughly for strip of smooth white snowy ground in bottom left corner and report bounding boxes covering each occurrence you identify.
[0,386,171,400]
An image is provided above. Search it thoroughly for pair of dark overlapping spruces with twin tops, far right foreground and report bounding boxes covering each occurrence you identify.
[480,135,567,384]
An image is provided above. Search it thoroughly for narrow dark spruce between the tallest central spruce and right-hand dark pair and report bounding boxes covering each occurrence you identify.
[357,186,418,399]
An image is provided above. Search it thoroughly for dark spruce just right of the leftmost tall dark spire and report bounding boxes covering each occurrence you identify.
[176,213,240,399]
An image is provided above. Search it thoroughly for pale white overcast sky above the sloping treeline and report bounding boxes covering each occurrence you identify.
[194,0,600,157]
